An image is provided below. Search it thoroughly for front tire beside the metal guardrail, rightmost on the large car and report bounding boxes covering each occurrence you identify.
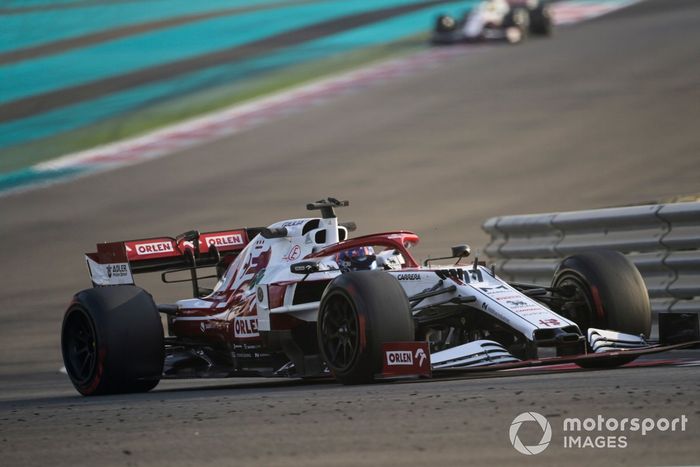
[552,250,651,368]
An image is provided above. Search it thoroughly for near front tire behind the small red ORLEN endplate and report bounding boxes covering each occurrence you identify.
[317,271,415,384]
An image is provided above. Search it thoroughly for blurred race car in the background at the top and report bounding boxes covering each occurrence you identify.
[431,0,552,45]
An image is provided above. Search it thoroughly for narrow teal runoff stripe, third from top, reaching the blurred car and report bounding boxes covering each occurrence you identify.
[0,0,476,148]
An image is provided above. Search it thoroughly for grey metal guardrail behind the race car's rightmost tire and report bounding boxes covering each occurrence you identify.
[483,202,700,315]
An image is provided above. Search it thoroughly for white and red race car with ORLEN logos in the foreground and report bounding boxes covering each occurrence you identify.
[61,198,680,395]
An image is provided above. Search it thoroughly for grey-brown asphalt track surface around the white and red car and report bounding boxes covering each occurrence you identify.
[0,0,700,465]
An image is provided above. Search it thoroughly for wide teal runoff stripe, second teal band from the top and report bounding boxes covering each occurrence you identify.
[0,0,427,102]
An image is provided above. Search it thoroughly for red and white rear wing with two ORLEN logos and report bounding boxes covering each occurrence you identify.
[85,228,261,296]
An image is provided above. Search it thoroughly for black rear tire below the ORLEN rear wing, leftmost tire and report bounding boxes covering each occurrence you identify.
[61,285,165,396]
